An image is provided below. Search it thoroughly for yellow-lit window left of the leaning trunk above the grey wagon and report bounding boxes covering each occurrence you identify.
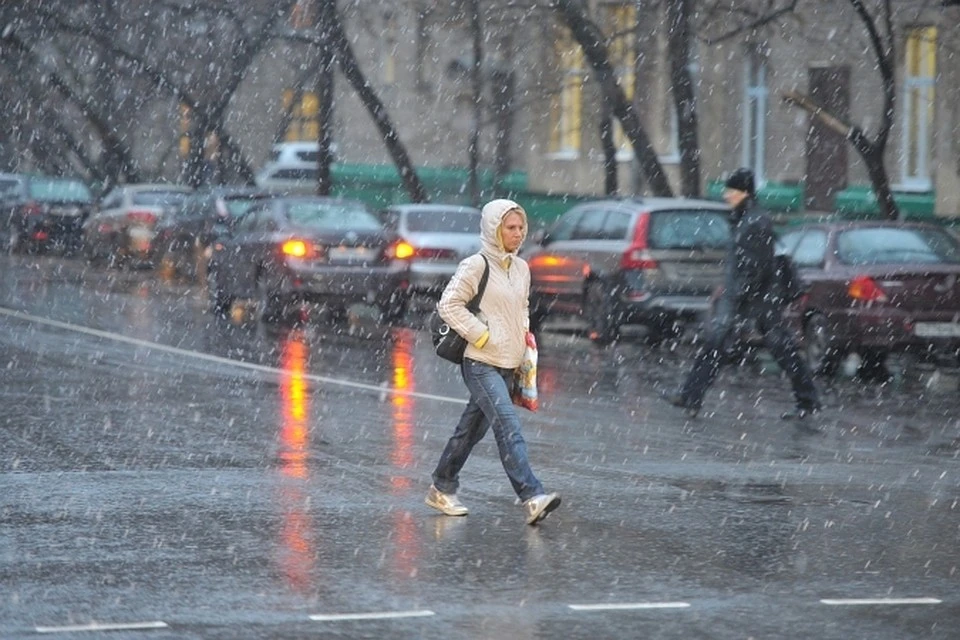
[549,33,584,158]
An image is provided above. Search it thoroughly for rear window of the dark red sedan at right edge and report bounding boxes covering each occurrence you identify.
[837,227,960,265]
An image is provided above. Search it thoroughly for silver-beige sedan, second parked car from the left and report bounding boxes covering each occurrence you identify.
[83,183,193,265]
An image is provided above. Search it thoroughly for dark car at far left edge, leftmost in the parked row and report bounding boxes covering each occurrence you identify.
[0,174,93,253]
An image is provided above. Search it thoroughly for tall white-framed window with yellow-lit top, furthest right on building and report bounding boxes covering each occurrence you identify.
[900,27,937,191]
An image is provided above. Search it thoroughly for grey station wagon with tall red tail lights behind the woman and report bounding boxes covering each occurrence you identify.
[523,198,730,344]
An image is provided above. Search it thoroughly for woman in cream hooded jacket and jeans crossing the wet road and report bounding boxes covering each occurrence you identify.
[426,200,560,525]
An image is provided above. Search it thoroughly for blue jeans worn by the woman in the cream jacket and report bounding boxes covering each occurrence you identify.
[433,358,543,500]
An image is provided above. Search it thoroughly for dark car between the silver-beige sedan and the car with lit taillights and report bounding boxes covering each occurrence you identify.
[153,185,277,280]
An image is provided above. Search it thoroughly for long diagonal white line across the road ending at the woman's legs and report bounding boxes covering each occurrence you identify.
[0,307,465,405]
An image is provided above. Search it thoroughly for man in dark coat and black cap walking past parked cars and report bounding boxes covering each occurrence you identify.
[663,168,820,419]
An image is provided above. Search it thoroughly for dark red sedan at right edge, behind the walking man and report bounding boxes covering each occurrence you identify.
[781,221,960,375]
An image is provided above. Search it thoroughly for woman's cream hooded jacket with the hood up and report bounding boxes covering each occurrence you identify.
[437,200,530,369]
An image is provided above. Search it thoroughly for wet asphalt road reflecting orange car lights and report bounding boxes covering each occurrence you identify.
[0,252,960,640]
